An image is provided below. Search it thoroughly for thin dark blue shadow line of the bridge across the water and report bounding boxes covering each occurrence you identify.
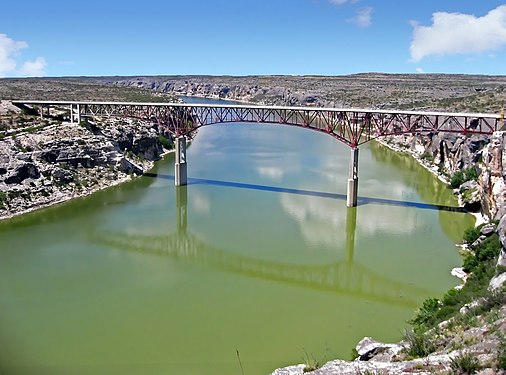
[144,172,469,213]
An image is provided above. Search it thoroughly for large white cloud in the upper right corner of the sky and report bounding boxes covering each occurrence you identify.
[410,5,506,62]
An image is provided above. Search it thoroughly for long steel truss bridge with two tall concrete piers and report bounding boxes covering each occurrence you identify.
[12,100,504,207]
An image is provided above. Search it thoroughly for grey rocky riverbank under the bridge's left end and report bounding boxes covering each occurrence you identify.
[0,106,171,220]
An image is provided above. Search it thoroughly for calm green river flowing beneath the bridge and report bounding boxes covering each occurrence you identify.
[0,97,474,375]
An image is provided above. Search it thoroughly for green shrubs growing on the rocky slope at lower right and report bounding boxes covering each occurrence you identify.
[404,220,506,368]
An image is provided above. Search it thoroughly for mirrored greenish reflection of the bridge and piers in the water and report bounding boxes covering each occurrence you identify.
[95,186,434,308]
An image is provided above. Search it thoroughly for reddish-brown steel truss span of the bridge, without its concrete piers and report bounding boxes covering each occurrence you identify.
[80,104,500,147]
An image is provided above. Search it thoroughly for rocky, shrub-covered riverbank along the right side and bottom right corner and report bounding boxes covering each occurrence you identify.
[272,132,506,375]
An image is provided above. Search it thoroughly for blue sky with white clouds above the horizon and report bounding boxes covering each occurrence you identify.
[0,0,506,77]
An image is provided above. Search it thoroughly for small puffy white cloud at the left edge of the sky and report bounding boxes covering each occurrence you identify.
[0,34,47,77]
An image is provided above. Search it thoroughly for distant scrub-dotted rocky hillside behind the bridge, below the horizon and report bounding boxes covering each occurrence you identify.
[99,73,506,113]
